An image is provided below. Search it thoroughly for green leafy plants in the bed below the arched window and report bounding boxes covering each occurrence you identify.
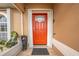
[0,31,18,50]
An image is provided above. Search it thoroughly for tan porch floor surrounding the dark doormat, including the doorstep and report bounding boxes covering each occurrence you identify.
[17,45,63,56]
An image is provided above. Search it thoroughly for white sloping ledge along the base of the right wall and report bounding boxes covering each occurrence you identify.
[53,38,79,56]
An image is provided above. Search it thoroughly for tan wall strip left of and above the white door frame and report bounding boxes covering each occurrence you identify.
[23,4,53,35]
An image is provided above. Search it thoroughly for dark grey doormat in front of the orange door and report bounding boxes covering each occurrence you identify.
[32,48,49,55]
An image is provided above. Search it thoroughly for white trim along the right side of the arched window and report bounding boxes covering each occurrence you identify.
[0,8,11,40]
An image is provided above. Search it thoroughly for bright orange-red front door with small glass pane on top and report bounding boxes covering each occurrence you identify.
[32,13,47,44]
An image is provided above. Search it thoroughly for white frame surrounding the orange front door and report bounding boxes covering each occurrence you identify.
[28,9,53,48]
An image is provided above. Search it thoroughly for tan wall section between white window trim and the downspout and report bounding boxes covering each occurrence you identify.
[11,9,21,35]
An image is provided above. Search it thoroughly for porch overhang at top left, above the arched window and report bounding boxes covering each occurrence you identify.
[0,3,24,12]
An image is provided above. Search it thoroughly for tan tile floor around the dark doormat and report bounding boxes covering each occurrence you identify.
[17,45,62,56]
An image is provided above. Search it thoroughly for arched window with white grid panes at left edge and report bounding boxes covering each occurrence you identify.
[0,14,8,40]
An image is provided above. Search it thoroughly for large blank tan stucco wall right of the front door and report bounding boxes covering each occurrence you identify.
[54,4,79,51]
